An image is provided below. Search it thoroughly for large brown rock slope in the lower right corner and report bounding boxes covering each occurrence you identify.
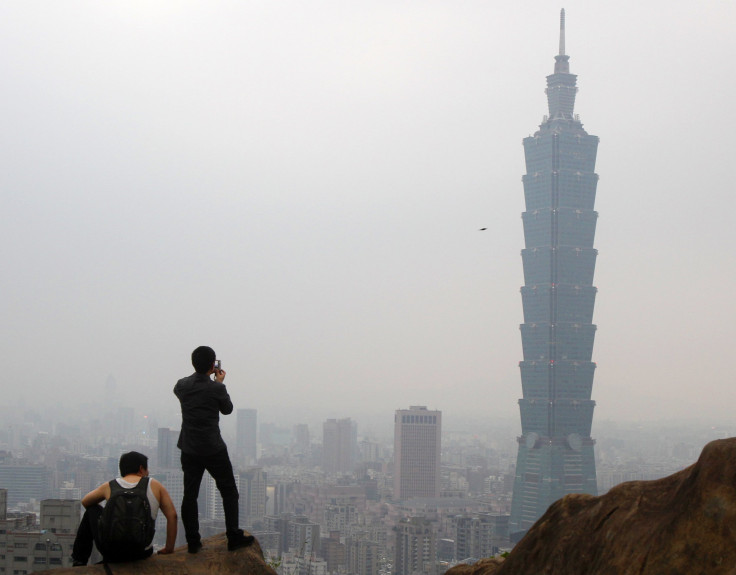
[447,438,736,575]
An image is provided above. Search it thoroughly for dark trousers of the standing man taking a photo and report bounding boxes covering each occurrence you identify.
[181,448,240,544]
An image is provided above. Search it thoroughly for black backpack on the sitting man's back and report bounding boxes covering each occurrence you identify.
[99,477,156,561]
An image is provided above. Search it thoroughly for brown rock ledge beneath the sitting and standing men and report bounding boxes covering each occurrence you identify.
[44,533,276,575]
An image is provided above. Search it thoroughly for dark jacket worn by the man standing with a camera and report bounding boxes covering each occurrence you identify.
[174,373,233,455]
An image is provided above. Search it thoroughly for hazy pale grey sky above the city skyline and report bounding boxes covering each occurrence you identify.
[0,0,736,432]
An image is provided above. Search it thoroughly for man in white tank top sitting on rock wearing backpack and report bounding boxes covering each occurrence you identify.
[72,451,177,567]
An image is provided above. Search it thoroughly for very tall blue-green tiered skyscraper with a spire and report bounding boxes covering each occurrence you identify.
[510,10,598,540]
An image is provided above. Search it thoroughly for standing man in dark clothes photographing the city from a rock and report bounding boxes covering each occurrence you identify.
[174,346,253,553]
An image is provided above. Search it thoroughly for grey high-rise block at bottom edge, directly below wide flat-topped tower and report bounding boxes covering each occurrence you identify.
[393,517,437,575]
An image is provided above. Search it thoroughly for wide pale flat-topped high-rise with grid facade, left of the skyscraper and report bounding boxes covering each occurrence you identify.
[394,405,442,500]
